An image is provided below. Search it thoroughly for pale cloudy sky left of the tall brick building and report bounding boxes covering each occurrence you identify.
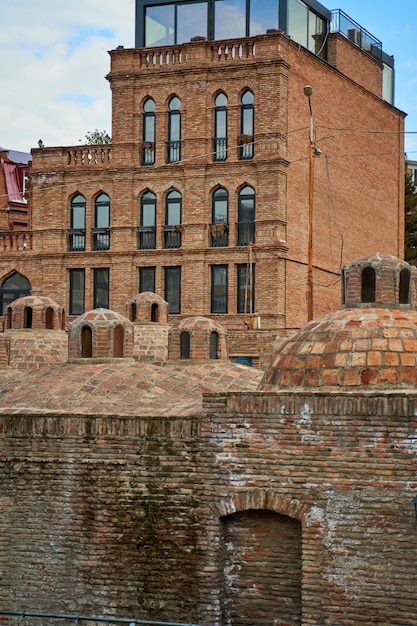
[0,0,135,151]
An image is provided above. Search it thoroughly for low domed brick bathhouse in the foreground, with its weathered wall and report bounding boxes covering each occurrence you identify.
[0,254,417,626]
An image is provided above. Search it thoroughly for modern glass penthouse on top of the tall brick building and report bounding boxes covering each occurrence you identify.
[135,0,394,104]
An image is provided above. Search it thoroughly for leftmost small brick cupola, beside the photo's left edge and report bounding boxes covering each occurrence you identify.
[5,296,65,330]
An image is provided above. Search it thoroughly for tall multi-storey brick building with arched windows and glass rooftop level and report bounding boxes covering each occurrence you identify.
[0,0,404,358]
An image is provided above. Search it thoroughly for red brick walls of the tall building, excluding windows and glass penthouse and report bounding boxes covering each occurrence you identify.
[0,33,404,358]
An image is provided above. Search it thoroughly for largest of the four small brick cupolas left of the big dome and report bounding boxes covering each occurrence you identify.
[68,309,133,359]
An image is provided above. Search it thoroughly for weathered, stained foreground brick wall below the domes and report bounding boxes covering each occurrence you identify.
[0,392,417,626]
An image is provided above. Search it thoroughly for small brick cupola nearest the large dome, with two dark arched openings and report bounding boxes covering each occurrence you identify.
[169,316,227,361]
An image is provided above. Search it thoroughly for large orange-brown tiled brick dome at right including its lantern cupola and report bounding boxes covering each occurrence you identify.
[261,255,417,390]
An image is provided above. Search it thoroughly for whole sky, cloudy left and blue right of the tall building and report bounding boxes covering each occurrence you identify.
[0,0,417,155]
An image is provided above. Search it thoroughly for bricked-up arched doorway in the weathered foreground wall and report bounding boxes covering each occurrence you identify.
[220,510,302,626]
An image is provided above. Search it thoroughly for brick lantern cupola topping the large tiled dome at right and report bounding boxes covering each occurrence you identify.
[342,253,416,308]
